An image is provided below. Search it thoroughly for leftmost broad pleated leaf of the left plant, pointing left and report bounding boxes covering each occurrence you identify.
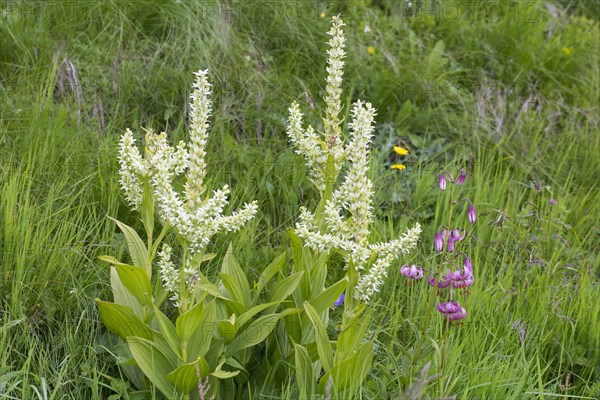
[96,299,152,340]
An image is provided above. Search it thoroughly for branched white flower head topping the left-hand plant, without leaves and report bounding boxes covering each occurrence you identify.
[119,71,258,253]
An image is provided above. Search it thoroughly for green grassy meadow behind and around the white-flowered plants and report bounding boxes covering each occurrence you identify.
[0,0,600,399]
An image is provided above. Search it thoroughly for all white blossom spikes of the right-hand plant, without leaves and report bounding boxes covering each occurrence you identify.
[288,17,421,301]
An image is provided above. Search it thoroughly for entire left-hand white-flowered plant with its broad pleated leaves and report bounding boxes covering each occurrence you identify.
[97,71,300,399]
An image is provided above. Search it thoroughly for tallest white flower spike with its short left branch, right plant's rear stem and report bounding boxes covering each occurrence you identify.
[287,16,346,192]
